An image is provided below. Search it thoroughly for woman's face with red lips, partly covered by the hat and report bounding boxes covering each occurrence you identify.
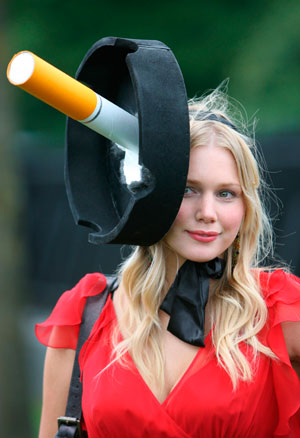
[165,139,245,265]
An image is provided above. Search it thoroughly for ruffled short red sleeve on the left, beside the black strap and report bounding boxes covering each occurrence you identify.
[35,273,106,350]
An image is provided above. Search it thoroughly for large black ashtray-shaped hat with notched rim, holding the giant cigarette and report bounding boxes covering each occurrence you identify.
[65,37,190,246]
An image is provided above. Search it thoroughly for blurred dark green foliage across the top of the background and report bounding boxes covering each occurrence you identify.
[8,0,300,142]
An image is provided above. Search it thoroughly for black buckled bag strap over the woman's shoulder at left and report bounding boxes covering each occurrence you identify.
[55,277,117,438]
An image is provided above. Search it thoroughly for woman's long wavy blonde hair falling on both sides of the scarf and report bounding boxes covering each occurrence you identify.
[114,87,275,388]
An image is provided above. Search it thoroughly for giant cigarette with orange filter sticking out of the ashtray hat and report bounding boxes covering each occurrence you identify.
[7,51,139,155]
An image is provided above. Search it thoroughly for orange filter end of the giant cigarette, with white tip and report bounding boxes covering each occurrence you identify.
[7,51,97,121]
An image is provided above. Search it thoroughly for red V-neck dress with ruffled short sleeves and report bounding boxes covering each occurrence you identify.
[36,270,300,438]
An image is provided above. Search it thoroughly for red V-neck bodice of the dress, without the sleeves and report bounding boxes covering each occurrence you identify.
[82,335,277,438]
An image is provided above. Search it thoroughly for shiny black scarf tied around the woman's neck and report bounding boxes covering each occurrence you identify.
[160,258,225,347]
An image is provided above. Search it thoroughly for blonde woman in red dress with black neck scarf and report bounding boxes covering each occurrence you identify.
[36,90,300,438]
